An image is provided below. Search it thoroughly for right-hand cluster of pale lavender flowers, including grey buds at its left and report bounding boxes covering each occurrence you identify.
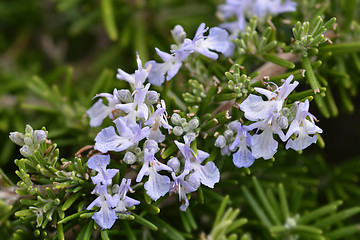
[215,75,322,167]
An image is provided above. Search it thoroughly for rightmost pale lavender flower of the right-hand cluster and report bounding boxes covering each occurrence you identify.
[285,99,322,151]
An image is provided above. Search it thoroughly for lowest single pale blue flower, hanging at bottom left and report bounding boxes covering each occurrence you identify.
[86,185,118,229]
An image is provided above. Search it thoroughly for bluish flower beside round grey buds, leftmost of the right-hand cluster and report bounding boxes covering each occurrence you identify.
[229,122,255,168]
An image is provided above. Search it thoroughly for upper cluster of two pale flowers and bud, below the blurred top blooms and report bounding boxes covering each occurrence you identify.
[146,23,234,86]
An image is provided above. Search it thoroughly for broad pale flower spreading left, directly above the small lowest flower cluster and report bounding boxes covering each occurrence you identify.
[94,117,150,153]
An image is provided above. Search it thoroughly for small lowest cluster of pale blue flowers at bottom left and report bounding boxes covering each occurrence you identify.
[87,155,140,229]
